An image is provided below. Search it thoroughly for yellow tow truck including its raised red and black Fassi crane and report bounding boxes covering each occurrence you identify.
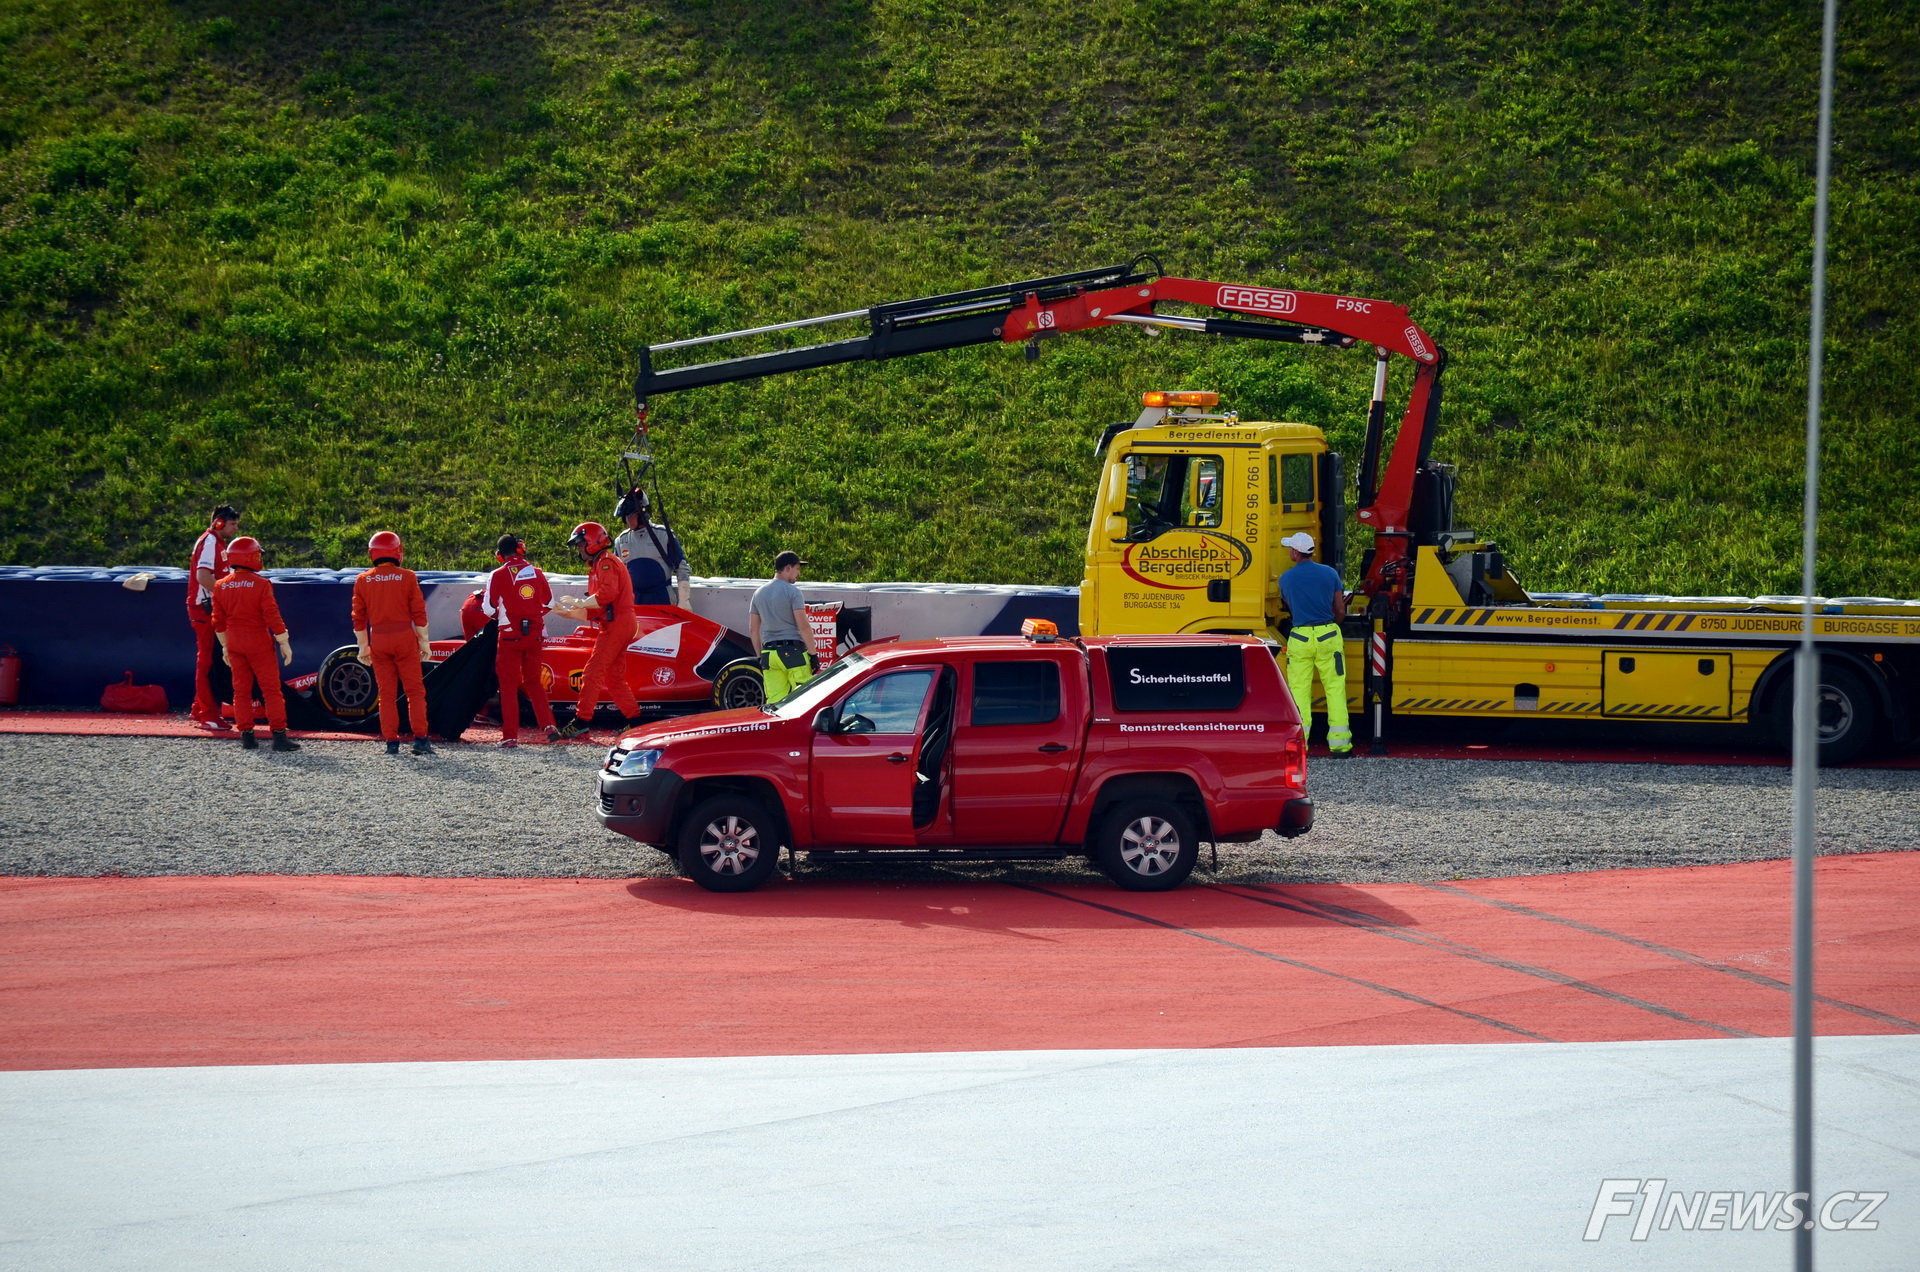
[634,263,1920,763]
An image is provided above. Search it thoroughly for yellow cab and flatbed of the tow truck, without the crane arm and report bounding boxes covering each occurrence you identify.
[1079,392,1920,763]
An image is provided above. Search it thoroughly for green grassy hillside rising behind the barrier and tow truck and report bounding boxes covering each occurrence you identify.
[0,0,1920,596]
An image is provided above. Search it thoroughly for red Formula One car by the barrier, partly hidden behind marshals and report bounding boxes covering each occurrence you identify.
[313,605,766,737]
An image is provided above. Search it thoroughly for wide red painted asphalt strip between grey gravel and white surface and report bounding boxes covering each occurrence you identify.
[0,853,1920,1070]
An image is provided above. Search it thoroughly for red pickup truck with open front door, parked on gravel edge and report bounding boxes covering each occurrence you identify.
[597,636,1313,892]
